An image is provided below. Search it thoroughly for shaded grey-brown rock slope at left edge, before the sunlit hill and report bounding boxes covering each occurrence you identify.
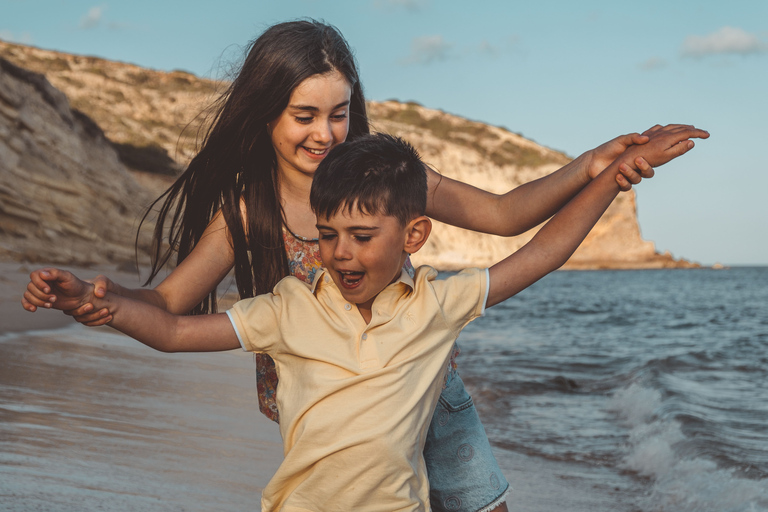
[0,55,156,264]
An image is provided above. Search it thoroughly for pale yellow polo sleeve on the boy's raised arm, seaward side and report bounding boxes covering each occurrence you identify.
[432,268,488,334]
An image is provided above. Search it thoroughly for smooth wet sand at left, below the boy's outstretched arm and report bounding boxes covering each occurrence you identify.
[0,262,282,512]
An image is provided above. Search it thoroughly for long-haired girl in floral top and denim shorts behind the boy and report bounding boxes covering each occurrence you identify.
[22,21,696,511]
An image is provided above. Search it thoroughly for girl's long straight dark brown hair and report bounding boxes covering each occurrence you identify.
[142,20,369,314]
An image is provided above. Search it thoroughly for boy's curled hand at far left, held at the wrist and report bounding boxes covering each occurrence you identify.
[21,268,95,312]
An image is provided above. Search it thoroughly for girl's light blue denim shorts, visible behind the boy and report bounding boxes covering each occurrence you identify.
[424,372,509,512]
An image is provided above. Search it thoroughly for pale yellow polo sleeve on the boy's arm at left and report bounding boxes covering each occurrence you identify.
[227,289,283,353]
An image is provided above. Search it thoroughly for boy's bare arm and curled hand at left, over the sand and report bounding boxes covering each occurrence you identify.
[25,268,240,352]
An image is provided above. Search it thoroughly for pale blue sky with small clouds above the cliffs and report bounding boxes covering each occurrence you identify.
[0,0,768,265]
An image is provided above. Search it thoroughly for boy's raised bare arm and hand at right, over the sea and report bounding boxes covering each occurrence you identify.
[486,126,708,307]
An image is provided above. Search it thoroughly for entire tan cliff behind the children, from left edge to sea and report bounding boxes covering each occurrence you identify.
[0,41,691,269]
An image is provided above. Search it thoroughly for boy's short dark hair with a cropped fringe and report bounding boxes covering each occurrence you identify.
[309,133,427,225]
